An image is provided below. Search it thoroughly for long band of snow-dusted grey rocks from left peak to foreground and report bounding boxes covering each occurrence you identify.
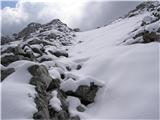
[1,19,99,120]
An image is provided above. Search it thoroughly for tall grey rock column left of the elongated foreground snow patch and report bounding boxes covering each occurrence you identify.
[28,65,52,120]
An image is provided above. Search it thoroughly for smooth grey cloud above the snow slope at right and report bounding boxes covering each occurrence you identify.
[79,1,140,30]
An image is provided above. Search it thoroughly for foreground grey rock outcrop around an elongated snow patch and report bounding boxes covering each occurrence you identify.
[28,65,80,120]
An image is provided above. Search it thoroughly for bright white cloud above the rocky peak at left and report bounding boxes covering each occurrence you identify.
[0,0,86,34]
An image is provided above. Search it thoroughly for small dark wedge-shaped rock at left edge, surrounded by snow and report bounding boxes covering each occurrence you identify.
[1,68,15,82]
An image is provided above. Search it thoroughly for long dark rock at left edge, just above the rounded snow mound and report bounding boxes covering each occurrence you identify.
[1,55,30,66]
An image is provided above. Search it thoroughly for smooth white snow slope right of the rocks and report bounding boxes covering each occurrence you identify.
[69,13,159,120]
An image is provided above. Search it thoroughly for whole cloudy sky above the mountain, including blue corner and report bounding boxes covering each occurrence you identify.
[0,0,140,35]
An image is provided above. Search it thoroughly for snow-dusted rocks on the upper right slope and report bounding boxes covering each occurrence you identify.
[124,1,160,44]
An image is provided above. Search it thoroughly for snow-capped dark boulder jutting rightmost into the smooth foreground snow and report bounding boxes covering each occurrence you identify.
[61,77,103,105]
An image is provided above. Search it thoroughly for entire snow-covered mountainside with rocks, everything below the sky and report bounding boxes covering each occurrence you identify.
[1,2,160,120]
